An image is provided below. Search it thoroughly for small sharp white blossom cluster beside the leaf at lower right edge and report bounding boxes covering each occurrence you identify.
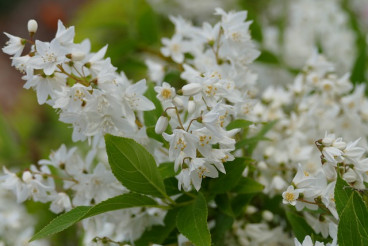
[282,133,368,245]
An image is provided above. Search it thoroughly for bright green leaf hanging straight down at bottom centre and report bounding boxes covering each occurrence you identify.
[176,193,211,246]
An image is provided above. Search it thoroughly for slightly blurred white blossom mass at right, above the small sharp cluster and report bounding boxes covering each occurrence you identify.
[252,54,368,195]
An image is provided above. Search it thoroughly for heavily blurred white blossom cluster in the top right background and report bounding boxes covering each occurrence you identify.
[263,0,356,71]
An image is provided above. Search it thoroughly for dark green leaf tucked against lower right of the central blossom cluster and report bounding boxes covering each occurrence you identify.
[210,158,246,194]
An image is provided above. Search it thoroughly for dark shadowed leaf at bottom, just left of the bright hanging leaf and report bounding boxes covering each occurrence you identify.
[134,209,178,246]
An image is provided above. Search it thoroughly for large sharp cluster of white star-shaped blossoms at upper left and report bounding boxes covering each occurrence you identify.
[3,21,154,141]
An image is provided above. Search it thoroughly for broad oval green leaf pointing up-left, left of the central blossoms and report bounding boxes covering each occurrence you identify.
[105,135,166,197]
